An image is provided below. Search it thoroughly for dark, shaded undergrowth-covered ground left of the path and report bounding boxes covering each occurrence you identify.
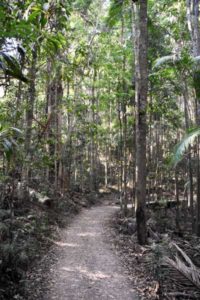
[0,187,98,300]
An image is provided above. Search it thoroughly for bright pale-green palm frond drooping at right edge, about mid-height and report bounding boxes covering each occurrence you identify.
[172,128,200,167]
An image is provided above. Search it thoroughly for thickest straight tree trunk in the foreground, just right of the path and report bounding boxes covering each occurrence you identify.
[135,0,148,244]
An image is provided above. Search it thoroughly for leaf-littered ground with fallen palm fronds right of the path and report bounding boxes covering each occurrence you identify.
[111,205,200,300]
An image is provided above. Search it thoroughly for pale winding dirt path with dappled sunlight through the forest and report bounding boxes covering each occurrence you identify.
[39,204,139,300]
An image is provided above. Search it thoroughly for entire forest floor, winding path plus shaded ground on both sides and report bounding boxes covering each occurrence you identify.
[0,191,200,300]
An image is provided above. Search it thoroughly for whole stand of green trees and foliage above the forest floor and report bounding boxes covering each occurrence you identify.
[0,0,200,298]
